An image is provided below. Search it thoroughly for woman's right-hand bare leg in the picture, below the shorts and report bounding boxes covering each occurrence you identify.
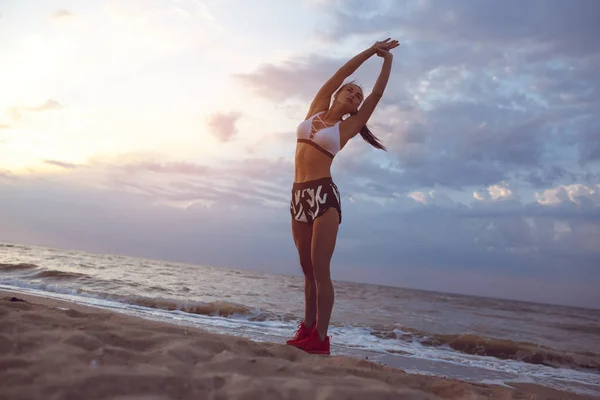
[311,207,340,340]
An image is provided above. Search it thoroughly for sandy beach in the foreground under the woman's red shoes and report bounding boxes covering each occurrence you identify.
[0,291,590,400]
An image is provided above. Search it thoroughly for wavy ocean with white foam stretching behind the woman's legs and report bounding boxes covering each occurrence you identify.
[0,243,600,396]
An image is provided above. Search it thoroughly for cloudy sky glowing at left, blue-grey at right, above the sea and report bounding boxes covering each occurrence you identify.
[0,0,600,308]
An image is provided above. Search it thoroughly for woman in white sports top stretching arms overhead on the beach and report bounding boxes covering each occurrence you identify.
[286,38,399,354]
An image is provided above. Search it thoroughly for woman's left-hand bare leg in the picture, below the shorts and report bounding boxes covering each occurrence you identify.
[292,218,317,327]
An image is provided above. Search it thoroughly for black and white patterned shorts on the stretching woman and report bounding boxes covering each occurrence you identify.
[290,177,342,224]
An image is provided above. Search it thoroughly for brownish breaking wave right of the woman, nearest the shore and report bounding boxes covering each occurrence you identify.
[372,328,600,371]
